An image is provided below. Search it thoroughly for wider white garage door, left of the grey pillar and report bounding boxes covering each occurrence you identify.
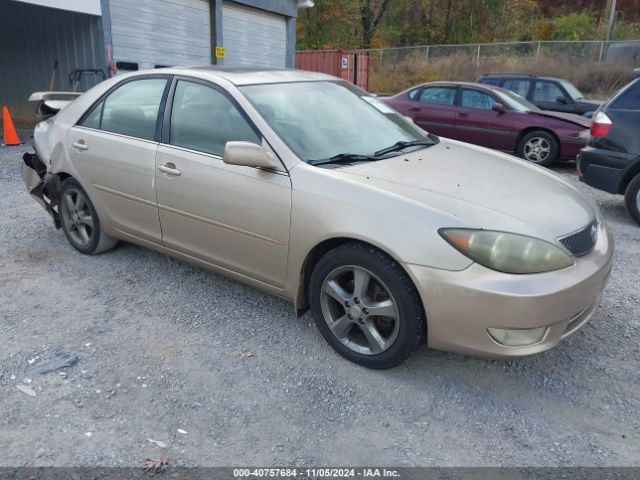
[109,0,211,69]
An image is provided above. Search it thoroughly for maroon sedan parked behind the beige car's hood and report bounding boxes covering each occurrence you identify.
[381,82,590,165]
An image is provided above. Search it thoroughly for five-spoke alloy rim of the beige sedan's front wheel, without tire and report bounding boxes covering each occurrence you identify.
[320,266,400,355]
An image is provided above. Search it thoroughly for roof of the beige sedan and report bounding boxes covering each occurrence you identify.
[122,65,338,86]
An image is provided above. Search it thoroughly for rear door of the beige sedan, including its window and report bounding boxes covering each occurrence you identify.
[67,76,169,244]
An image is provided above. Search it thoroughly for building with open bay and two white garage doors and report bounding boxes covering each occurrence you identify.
[0,0,313,125]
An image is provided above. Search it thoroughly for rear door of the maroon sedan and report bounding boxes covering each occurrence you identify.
[407,85,458,138]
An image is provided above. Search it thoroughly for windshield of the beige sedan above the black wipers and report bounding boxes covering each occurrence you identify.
[240,81,432,163]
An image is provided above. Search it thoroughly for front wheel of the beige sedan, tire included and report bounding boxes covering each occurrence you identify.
[309,243,425,369]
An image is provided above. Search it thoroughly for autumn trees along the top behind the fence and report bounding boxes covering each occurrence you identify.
[298,0,640,50]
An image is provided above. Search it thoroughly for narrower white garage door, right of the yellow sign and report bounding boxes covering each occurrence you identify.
[222,2,287,67]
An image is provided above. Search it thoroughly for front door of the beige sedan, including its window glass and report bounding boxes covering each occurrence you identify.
[156,80,291,288]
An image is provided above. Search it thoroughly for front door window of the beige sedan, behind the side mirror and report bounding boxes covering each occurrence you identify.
[169,80,261,156]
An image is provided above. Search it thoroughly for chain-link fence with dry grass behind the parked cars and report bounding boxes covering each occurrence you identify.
[344,40,640,97]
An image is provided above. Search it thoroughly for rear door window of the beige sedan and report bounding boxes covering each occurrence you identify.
[99,78,167,140]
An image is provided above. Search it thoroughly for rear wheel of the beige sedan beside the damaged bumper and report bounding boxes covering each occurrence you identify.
[59,178,118,255]
